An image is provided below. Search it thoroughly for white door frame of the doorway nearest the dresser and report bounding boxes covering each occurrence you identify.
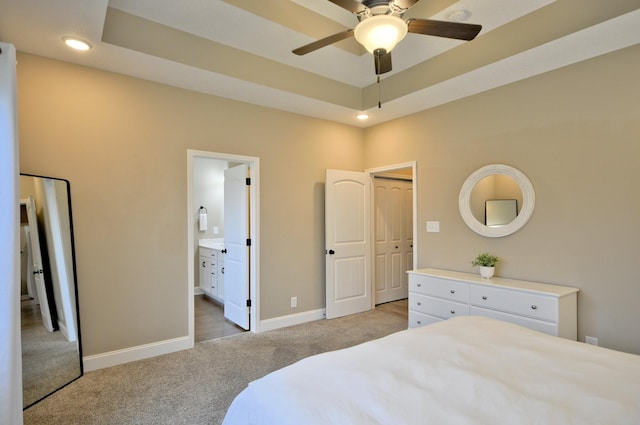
[364,161,418,309]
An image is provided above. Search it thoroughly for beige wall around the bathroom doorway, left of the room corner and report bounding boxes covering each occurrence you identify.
[18,54,364,355]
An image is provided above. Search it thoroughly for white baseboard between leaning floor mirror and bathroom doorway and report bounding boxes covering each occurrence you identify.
[82,336,193,372]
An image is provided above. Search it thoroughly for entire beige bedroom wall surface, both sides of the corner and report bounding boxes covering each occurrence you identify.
[18,41,640,355]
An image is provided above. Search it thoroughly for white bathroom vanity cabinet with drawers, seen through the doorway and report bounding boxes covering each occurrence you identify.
[198,239,225,302]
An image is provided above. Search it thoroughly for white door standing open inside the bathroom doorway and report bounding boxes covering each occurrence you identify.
[224,164,249,329]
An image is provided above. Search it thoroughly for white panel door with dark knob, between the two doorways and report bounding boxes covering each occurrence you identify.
[325,170,372,319]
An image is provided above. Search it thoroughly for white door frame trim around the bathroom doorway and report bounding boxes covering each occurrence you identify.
[187,149,260,348]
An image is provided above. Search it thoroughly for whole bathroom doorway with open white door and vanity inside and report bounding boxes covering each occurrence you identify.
[187,150,259,345]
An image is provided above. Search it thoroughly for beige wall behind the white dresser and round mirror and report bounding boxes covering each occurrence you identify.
[365,46,640,353]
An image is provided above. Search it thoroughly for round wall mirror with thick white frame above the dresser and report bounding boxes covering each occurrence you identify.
[458,164,535,238]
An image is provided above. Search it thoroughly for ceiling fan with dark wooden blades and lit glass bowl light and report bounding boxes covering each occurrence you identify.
[292,0,482,76]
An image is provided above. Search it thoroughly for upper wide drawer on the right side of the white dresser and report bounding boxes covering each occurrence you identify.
[469,285,558,322]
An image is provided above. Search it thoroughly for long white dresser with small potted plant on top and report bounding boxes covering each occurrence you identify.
[408,269,578,340]
